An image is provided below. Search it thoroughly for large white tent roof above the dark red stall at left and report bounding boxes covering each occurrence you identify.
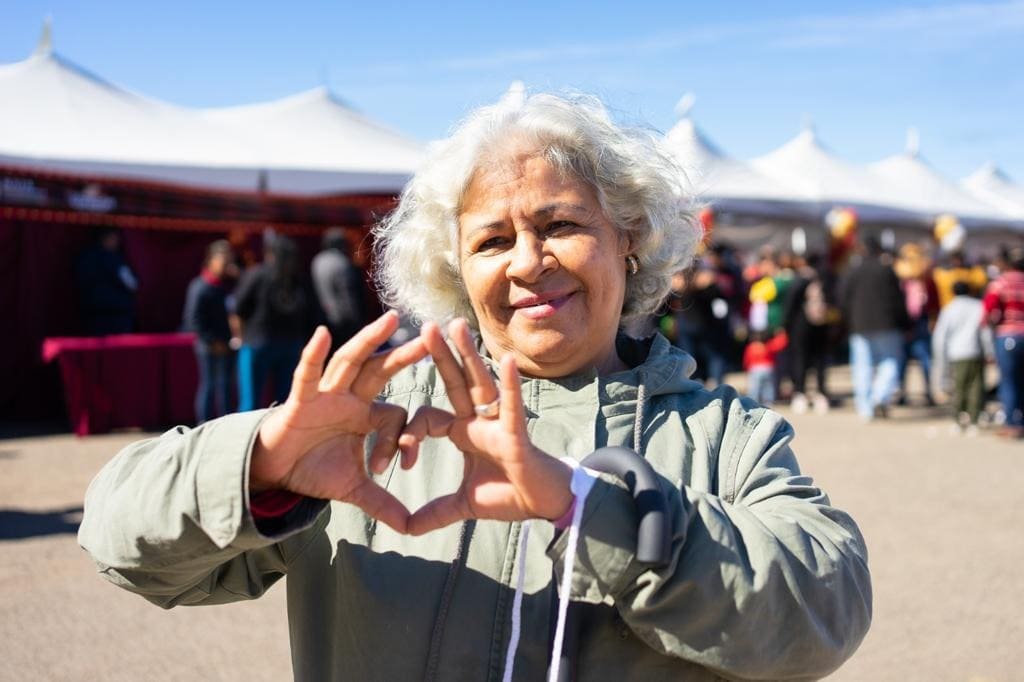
[0,30,421,195]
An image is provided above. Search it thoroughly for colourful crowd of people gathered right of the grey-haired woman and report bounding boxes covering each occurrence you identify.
[659,232,1024,438]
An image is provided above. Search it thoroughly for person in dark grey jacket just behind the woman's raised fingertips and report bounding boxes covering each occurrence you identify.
[310,227,370,350]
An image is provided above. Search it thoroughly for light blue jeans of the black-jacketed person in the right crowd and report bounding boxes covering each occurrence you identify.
[850,331,903,419]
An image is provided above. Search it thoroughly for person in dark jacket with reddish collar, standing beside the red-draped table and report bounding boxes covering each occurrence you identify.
[181,240,234,424]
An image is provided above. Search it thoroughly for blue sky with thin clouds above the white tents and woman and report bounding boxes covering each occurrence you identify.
[6,0,1024,183]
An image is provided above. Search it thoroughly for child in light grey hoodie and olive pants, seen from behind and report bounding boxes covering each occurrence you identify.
[932,282,992,435]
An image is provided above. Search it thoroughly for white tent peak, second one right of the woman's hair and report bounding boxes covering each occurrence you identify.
[751,128,920,222]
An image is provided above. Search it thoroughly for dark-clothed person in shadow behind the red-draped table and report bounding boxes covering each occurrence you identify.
[75,227,138,336]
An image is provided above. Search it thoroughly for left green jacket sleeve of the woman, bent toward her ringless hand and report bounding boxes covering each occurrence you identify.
[78,411,328,608]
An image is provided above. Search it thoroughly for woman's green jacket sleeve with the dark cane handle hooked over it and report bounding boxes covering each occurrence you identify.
[549,400,871,680]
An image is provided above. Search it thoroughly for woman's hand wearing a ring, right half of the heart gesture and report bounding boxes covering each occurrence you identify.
[398,319,572,535]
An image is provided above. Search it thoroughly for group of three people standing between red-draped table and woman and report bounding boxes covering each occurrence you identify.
[182,228,368,423]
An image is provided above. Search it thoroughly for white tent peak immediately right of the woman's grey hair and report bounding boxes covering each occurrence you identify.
[665,116,813,217]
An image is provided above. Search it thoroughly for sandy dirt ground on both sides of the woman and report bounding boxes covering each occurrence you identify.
[0,368,1024,682]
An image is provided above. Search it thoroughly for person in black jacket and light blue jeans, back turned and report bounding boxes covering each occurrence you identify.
[843,238,910,421]
